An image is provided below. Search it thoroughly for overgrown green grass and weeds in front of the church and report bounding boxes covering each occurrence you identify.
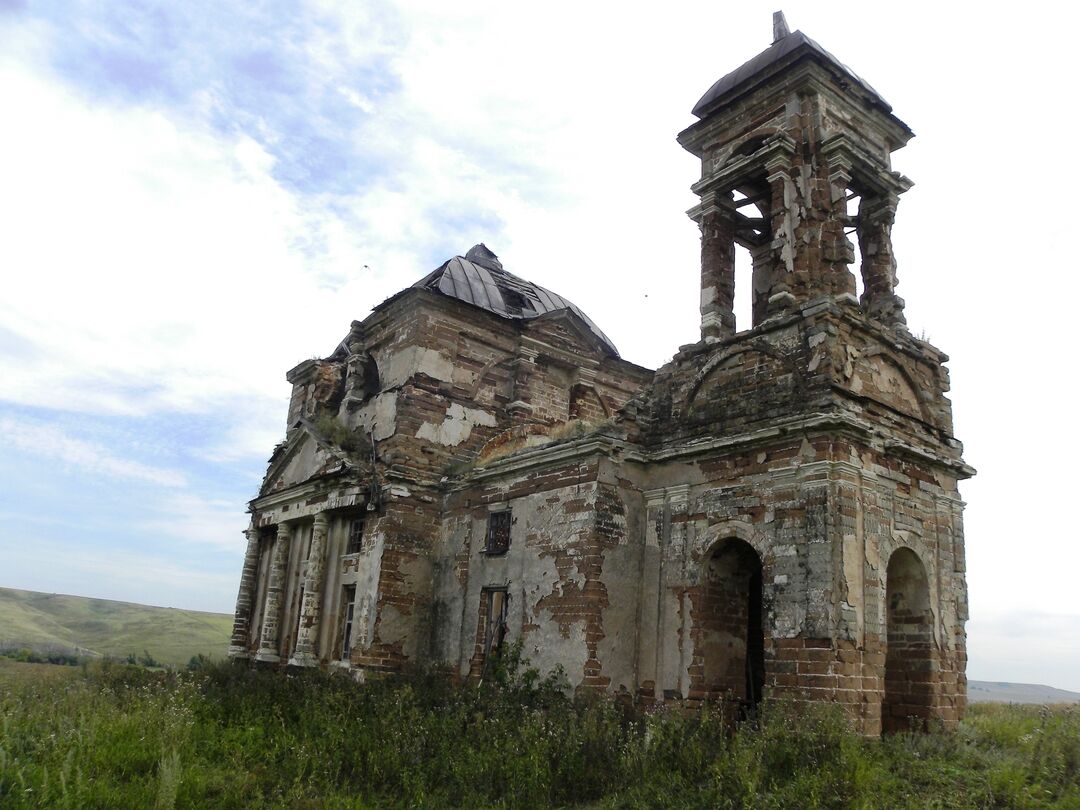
[0,663,1080,810]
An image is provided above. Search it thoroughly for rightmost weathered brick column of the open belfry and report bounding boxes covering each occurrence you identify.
[859,193,907,326]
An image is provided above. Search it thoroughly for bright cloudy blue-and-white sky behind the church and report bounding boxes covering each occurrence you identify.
[0,0,1080,690]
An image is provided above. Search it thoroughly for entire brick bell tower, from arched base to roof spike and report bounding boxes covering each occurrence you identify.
[627,14,975,735]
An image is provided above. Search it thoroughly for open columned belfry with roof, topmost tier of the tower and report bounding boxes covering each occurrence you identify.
[678,12,913,340]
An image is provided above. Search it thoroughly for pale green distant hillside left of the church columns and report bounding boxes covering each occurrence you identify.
[0,588,232,665]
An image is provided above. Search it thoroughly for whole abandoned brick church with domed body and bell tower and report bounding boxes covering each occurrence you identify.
[230,15,974,734]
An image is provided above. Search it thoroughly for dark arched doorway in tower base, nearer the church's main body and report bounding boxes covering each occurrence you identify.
[694,538,765,708]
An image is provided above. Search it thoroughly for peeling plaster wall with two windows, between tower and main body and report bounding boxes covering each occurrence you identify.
[433,458,640,693]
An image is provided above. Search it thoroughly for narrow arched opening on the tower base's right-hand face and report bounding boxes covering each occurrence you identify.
[881,549,935,732]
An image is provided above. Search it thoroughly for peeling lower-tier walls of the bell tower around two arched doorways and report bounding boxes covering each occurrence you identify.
[638,436,967,733]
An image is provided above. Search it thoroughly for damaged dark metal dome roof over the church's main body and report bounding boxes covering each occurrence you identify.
[413,244,619,357]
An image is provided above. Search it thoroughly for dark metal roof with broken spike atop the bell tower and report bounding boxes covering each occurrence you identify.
[692,24,892,118]
